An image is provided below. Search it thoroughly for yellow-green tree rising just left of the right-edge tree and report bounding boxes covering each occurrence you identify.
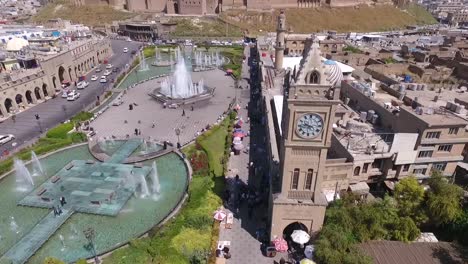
[394,177,427,225]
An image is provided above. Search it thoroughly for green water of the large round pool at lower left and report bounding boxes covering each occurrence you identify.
[0,143,189,263]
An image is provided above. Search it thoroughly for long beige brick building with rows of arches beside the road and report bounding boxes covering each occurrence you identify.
[0,39,112,119]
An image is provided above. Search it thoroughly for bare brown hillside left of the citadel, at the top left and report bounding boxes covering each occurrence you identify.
[31,0,135,26]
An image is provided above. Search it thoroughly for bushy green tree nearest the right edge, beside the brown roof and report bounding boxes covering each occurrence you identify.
[426,171,463,225]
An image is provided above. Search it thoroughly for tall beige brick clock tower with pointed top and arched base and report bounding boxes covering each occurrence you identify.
[270,38,342,241]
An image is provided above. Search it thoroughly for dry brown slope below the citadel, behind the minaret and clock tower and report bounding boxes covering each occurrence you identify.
[221,5,437,33]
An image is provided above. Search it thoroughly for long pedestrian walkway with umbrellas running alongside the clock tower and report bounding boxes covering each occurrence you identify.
[219,47,281,264]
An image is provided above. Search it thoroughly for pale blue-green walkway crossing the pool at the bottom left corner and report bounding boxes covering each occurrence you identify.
[0,209,74,264]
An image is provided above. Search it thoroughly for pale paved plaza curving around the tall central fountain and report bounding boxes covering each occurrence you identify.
[91,68,238,145]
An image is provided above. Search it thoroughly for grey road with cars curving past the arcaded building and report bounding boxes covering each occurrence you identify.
[0,40,141,154]
